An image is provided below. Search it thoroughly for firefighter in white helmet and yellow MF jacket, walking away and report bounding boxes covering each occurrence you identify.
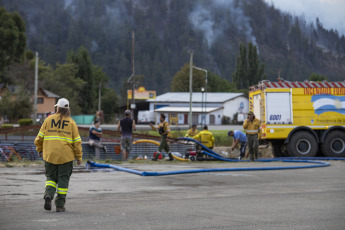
[35,98,83,212]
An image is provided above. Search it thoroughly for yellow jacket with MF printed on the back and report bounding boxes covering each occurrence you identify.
[35,114,83,164]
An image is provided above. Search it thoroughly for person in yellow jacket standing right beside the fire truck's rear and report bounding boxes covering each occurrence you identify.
[243,111,260,161]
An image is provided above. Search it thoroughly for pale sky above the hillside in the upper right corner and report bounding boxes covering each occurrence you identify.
[265,0,345,35]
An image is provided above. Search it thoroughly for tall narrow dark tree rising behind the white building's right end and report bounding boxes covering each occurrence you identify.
[232,43,265,89]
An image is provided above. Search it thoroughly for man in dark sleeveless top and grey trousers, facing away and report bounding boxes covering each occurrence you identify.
[117,110,136,161]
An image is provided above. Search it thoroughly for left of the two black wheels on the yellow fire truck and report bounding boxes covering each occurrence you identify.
[287,131,318,157]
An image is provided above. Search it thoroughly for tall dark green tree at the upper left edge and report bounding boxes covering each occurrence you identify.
[0,7,26,73]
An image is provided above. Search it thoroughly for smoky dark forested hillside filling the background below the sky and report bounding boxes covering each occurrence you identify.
[0,0,345,93]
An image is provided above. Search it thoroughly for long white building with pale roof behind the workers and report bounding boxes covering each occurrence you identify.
[147,92,249,125]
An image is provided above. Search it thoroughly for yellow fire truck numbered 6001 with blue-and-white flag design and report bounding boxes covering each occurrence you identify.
[249,78,345,157]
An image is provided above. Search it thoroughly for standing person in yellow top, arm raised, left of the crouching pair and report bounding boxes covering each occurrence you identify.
[150,113,174,161]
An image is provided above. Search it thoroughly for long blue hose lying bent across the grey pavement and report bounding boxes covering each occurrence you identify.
[85,159,330,176]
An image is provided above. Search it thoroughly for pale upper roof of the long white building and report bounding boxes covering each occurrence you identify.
[147,92,246,103]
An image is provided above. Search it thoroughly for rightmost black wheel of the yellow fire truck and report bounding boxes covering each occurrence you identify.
[322,131,345,157]
